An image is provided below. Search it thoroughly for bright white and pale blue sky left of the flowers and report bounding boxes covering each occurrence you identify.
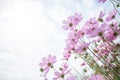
[0,0,112,80]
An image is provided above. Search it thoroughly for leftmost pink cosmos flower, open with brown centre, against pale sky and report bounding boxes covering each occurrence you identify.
[39,55,56,75]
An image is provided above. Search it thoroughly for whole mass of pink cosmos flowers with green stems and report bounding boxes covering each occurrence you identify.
[39,0,120,80]
